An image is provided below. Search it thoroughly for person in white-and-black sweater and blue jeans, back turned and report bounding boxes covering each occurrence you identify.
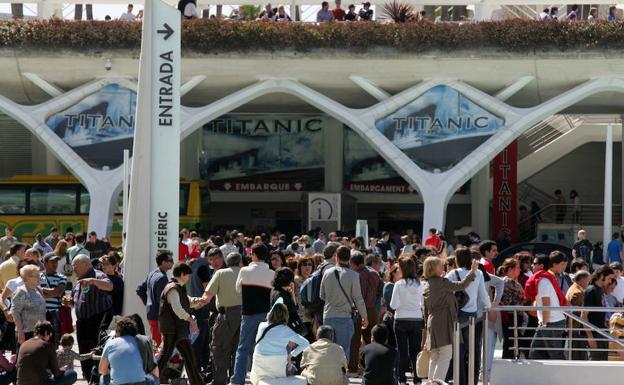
[230,243,275,385]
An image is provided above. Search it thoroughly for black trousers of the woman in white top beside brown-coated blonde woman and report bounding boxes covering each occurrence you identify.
[394,319,425,382]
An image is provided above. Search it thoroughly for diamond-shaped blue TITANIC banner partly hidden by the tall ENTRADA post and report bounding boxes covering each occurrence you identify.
[46,83,137,169]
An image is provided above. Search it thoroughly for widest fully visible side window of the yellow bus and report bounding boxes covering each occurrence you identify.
[30,187,76,214]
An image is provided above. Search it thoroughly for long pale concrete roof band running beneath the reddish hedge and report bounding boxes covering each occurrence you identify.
[0,49,624,113]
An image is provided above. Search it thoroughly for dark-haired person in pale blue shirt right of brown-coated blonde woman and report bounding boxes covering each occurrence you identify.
[446,247,491,385]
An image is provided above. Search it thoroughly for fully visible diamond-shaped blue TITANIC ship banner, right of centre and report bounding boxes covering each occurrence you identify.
[375,85,505,171]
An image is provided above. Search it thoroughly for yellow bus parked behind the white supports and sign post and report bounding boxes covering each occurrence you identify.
[0,175,208,245]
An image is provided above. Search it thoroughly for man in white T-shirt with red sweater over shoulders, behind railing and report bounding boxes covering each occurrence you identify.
[529,251,568,360]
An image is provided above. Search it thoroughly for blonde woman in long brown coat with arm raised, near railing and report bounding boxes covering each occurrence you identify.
[423,254,479,381]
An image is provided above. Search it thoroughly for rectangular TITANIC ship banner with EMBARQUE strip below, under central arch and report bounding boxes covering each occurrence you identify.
[199,115,324,192]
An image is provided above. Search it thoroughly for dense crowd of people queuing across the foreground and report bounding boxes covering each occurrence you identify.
[0,224,624,385]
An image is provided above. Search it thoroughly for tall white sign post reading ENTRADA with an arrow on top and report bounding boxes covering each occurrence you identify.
[124,0,181,314]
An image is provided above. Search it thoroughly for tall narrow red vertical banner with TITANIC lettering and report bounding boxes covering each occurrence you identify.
[492,141,518,243]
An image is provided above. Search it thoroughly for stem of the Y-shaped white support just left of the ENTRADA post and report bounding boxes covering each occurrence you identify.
[85,184,122,238]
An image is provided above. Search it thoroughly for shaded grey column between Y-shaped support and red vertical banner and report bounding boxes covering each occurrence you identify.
[470,165,491,239]
